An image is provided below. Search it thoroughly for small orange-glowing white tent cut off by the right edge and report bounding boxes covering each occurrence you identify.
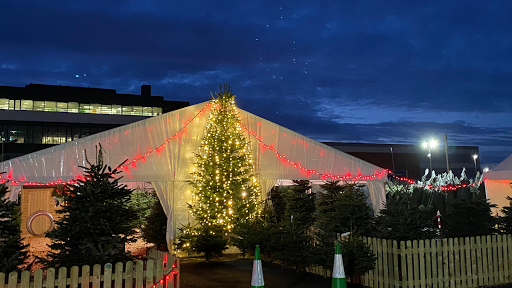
[484,155,512,215]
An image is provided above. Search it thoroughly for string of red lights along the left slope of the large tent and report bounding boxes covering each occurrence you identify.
[10,103,212,186]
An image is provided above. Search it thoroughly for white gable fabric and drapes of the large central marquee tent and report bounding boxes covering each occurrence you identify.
[0,102,387,245]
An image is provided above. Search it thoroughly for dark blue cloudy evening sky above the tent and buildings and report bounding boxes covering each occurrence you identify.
[0,0,512,165]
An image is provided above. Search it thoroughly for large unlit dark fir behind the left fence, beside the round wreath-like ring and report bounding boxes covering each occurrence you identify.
[45,145,137,267]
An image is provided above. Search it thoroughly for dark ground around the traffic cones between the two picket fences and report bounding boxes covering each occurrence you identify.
[180,256,331,288]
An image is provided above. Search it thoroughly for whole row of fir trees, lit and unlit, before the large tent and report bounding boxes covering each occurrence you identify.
[0,86,512,277]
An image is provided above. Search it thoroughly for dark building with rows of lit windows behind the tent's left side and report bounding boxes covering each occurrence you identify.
[0,84,189,161]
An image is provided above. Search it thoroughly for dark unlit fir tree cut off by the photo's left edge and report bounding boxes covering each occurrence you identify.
[0,183,28,274]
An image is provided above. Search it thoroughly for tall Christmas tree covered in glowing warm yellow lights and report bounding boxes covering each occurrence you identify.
[190,85,260,231]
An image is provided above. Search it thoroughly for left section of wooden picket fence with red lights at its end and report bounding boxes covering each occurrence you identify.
[0,250,180,288]
